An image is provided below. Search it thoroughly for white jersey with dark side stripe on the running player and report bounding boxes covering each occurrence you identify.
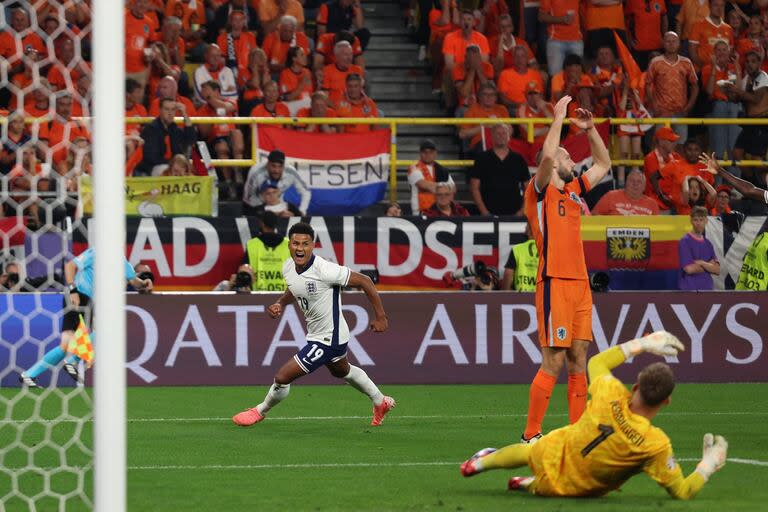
[283,254,352,346]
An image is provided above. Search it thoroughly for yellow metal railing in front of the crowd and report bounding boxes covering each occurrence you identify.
[76,117,768,201]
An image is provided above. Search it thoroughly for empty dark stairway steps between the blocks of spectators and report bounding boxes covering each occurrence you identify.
[363,0,468,212]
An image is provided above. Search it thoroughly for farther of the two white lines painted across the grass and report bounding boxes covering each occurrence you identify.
[0,411,768,425]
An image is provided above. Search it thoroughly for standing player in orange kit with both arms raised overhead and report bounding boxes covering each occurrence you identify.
[521,95,611,443]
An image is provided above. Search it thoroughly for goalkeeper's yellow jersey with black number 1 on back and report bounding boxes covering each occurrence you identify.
[529,374,685,496]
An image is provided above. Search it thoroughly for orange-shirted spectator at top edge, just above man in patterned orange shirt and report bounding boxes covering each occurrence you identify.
[626,0,669,69]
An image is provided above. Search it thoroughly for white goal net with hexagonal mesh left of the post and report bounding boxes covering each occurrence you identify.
[0,0,100,511]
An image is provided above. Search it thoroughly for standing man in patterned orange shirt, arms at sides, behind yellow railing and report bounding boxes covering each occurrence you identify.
[645,32,699,138]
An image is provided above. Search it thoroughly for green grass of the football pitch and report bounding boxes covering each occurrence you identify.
[0,383,768,512]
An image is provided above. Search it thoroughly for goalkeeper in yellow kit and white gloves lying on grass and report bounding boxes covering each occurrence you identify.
[461,331,728,499]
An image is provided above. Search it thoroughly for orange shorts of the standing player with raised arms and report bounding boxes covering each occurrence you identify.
[536,277,592,348]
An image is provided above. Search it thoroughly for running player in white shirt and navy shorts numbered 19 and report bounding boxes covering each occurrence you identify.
[232,222,395,427]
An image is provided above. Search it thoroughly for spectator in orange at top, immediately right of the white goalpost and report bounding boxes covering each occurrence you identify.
[125,0,158,90]
